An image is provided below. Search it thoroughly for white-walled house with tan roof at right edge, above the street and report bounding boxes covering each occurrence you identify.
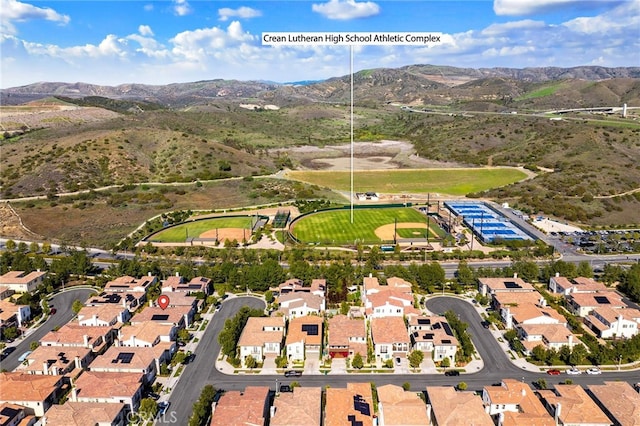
[584,306,640,339]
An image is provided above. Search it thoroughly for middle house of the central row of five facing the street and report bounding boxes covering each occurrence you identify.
[327,315,367,358]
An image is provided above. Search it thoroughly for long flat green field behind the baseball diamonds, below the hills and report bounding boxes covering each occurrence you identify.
[287,168,527,195]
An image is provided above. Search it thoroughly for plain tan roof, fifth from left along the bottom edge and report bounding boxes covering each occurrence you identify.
[424,386,494,426]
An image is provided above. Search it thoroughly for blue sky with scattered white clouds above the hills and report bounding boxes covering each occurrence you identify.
[0,0,640,88]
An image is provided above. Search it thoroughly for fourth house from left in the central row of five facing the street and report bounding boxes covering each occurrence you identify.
[371,317,411,361]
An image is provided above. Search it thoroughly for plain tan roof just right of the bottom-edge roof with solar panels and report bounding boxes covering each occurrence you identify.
[377,385,429,426]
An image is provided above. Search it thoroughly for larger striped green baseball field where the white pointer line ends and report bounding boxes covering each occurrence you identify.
[291,207,444,245]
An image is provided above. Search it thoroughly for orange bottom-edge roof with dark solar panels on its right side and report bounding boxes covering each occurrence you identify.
[323,383,375,426]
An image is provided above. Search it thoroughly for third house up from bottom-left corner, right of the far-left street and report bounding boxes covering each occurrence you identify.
[18,346,93,376]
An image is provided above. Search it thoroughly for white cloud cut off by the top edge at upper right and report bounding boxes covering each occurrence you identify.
[493,0,620,16]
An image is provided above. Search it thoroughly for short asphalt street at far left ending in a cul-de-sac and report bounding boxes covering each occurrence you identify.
[0,288,95,371]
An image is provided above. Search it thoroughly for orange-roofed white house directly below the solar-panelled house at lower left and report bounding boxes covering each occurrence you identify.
[70,371,143,412]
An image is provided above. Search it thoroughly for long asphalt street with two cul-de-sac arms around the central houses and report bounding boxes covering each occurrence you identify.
[157,296,640,424]
